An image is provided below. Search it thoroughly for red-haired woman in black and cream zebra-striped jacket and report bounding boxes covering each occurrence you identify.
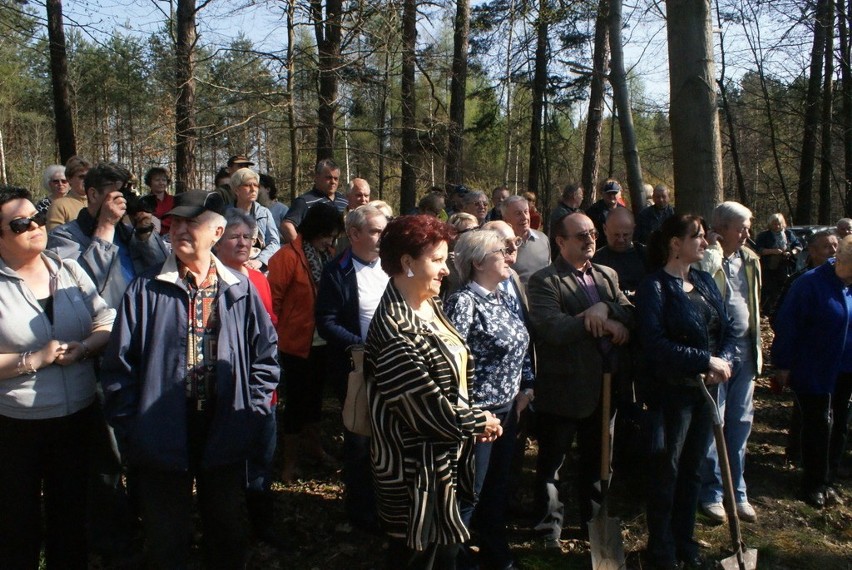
[365,215,502,569]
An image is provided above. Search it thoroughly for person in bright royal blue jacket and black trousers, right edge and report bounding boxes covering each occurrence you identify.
[772,236,852,508]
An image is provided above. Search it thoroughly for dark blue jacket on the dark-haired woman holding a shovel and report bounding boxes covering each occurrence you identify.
[636,269,736,384]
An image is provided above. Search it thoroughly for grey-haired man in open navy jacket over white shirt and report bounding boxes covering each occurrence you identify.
[316,204,388,531]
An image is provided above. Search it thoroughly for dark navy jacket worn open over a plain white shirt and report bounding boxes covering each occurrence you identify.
[315,248,364,386]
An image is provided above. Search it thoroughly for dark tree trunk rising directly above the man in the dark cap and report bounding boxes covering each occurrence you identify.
[175,0,198,192]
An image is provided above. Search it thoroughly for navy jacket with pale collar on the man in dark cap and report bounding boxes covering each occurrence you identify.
[101,255,279,471]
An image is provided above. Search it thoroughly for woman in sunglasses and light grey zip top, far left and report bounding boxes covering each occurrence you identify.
[0,186,115,569]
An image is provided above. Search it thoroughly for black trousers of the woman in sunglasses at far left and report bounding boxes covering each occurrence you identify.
[0,408,94,570]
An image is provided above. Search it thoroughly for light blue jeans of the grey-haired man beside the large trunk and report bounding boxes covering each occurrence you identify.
[700,353,757,503]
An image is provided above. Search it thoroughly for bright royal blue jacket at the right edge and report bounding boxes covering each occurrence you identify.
[772,260,852,394]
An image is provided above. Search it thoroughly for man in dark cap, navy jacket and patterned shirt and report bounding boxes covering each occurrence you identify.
[101,191,279,568]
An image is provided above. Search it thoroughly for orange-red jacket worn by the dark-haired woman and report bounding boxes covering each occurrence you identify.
[268,236,317,358]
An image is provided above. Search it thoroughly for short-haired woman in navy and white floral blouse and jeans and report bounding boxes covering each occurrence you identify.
[446,230,533,568]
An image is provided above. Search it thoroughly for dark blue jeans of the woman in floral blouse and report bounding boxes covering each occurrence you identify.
[459,405,518,568]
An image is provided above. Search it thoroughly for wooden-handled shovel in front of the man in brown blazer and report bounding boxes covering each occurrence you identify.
[587,355,625,570]
